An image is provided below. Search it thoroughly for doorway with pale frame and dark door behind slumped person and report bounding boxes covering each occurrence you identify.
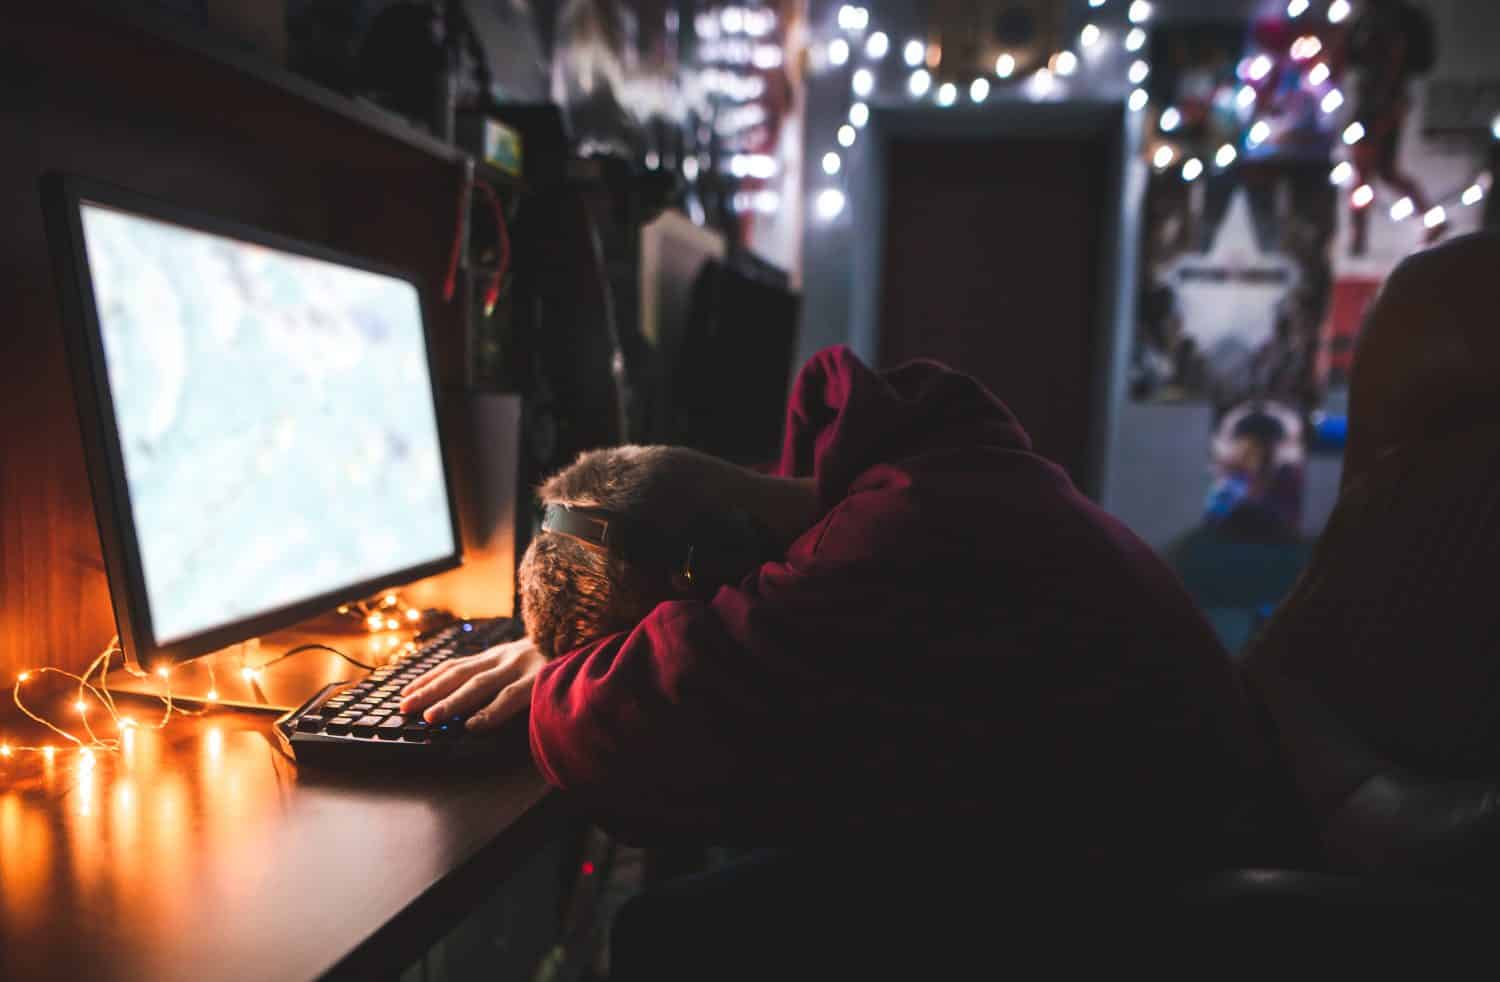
[861,105,1124,496]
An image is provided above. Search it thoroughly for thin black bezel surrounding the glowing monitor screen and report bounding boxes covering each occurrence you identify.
[42,174,464,670]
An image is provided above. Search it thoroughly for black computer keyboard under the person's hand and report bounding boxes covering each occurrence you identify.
[273,618,525,769]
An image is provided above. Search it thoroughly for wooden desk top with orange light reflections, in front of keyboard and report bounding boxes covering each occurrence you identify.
[0,702,560,982]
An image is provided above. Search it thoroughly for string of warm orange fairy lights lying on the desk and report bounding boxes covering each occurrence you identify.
[0,591,429,774]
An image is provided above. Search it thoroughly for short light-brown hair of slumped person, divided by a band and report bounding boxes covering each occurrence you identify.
[519,447,738,658]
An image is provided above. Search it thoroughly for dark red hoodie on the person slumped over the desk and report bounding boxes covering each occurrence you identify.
[531,348,1257,865]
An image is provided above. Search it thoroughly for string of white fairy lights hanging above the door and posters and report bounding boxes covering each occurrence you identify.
[812,0,1500,228]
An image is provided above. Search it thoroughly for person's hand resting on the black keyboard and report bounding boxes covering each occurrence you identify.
[401,637,548,730]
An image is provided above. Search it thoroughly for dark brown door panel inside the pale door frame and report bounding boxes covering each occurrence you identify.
[881,136,1112,490]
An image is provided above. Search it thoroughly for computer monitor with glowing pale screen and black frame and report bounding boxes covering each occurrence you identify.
[44,177,461,680]
